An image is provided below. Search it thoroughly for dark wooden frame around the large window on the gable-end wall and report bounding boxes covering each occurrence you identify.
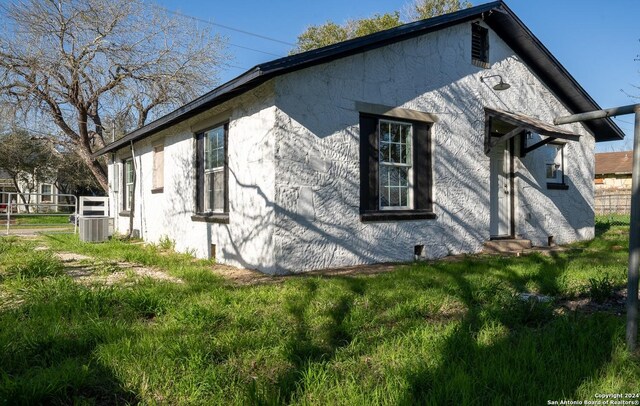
[360,112,436,222]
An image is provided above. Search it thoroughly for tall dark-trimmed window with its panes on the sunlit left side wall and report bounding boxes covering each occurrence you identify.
[192,123,229,223]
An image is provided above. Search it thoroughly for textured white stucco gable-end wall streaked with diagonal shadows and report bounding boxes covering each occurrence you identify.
[275,19,594,272]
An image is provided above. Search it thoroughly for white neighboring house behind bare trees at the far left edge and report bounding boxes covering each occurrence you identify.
[0,169,58,213]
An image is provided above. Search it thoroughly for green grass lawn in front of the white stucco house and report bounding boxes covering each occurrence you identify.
[0,221,640,405]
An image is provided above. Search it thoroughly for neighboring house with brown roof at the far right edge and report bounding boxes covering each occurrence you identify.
[595,151,633,191]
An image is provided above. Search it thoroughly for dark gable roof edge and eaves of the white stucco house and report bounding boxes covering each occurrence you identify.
[93,0,624,157]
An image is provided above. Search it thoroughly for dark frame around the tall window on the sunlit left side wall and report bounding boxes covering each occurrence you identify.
[191,121,229,223]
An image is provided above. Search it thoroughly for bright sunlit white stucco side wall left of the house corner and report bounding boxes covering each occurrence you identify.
[109,82,275,272]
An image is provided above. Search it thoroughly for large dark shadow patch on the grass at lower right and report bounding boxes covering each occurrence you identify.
[400,256,621,404]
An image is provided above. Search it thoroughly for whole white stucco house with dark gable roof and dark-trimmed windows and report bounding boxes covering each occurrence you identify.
[95,1,623,273]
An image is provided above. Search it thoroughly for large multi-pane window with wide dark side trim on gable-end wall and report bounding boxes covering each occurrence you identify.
[360,113,435,221]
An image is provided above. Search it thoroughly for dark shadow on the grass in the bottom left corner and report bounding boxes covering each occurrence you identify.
[0,277,152,404]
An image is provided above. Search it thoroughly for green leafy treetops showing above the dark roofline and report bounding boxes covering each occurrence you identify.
[290,0,471,54]
